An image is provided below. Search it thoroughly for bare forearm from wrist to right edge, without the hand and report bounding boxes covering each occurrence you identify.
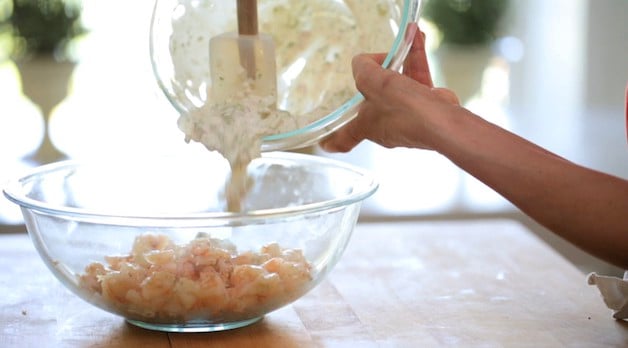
[433,112,628,269]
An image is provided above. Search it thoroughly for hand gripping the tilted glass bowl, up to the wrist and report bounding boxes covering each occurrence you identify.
[320,27,459,152]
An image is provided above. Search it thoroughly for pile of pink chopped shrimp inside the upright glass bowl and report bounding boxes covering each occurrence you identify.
[79,233,312,322]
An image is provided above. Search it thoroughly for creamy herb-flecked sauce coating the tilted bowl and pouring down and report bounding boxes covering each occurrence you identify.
[170,0,403,211]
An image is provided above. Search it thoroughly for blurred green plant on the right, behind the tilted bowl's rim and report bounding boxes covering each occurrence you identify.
[423,0,510,45]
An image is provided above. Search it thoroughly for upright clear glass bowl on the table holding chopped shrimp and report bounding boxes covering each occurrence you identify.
[4,153,377,332]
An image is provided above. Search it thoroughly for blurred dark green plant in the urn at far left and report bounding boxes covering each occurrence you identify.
[0,0,85,59]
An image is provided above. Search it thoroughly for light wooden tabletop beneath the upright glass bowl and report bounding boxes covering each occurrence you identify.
[0,220,628,348]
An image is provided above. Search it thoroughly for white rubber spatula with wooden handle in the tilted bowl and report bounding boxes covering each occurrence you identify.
[209,0,277,102]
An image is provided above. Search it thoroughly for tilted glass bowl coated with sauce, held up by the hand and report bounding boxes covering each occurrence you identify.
[150,0,421,151]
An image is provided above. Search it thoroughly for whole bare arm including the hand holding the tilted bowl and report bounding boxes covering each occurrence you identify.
[322,48,628,269]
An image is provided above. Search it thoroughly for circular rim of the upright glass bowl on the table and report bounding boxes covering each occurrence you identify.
[3,152,379,227]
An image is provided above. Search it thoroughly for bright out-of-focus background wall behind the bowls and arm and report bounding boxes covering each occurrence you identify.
[0,0,628,271]
